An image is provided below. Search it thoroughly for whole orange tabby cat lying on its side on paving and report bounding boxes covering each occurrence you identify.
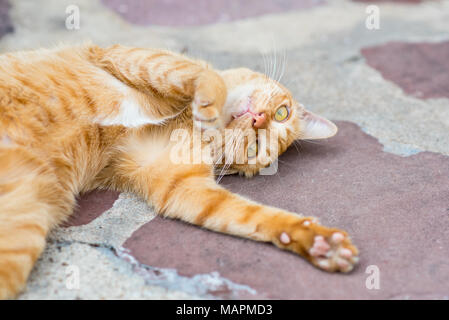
[0,45,357,298]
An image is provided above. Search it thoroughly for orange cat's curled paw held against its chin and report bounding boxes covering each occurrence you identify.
[192,70,227,130]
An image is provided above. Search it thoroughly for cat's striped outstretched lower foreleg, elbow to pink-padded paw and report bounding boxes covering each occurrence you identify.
[158,167,358,272]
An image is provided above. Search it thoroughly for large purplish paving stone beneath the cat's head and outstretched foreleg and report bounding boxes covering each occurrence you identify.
[124,122,449,299]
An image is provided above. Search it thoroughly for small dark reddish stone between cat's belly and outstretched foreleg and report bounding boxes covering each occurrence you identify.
[63,190,120,227]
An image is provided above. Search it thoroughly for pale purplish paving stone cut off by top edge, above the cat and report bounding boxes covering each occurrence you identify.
[102,0,324,26]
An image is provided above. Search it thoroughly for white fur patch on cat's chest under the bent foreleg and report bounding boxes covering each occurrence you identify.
[95,99,165,128]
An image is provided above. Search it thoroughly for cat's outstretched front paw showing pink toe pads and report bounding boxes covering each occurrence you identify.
[278,219,359,272]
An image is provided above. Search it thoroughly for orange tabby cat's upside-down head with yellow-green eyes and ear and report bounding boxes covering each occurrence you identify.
[214,68,337,176]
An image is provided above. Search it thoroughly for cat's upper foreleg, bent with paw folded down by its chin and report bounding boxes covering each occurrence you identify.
[89,45,227,129]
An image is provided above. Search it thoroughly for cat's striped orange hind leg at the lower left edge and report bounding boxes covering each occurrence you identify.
[0,146,74,299]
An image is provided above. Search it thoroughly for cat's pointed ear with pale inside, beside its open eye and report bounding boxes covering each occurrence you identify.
[299,111,338,140]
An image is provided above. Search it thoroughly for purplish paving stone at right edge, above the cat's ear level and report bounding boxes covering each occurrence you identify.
[362,41,449,99]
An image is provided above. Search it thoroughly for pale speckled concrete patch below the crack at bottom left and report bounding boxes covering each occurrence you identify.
[20,241,195,300]
